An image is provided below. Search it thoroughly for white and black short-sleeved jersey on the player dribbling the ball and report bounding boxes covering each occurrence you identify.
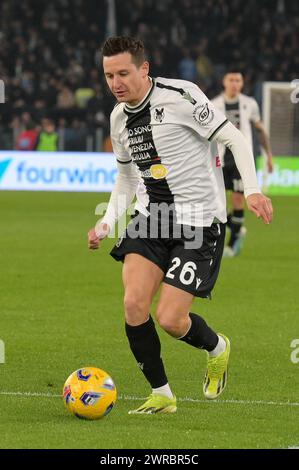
[111,78,227,226]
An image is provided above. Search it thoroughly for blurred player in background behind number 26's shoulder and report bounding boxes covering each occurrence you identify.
[212,70,273,258]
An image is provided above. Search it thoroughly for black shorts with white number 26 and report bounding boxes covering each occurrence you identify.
[110,213,225,298]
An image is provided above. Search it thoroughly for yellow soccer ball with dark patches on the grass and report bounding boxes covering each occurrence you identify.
[63,367,117,419]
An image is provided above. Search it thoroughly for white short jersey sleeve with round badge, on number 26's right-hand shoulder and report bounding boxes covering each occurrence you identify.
[180,85,227,140]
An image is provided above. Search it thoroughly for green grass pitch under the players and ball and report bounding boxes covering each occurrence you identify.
[0,192,299,449]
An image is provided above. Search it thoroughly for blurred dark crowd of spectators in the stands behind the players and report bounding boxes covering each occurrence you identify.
[0,0,299,149]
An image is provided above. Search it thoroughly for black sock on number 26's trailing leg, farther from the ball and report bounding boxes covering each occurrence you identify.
[180,313,219,351]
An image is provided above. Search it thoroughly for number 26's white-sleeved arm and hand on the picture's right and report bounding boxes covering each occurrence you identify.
[214,122,273,224]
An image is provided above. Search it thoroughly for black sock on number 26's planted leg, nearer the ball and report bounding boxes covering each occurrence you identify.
[126,317,168,388]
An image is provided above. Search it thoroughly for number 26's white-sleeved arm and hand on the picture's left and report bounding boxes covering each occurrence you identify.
[88,119,139,250]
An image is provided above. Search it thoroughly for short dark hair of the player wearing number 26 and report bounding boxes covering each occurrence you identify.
[101,36,146,67]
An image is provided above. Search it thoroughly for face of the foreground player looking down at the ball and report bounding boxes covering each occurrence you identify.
[103,52,149,105]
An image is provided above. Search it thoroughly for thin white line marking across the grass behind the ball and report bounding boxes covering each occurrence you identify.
[0,391,299,407]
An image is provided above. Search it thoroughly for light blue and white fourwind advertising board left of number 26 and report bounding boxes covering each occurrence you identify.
[0,151,117,192]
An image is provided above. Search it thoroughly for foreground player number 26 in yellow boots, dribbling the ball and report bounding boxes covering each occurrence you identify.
[88,37,272,414]
